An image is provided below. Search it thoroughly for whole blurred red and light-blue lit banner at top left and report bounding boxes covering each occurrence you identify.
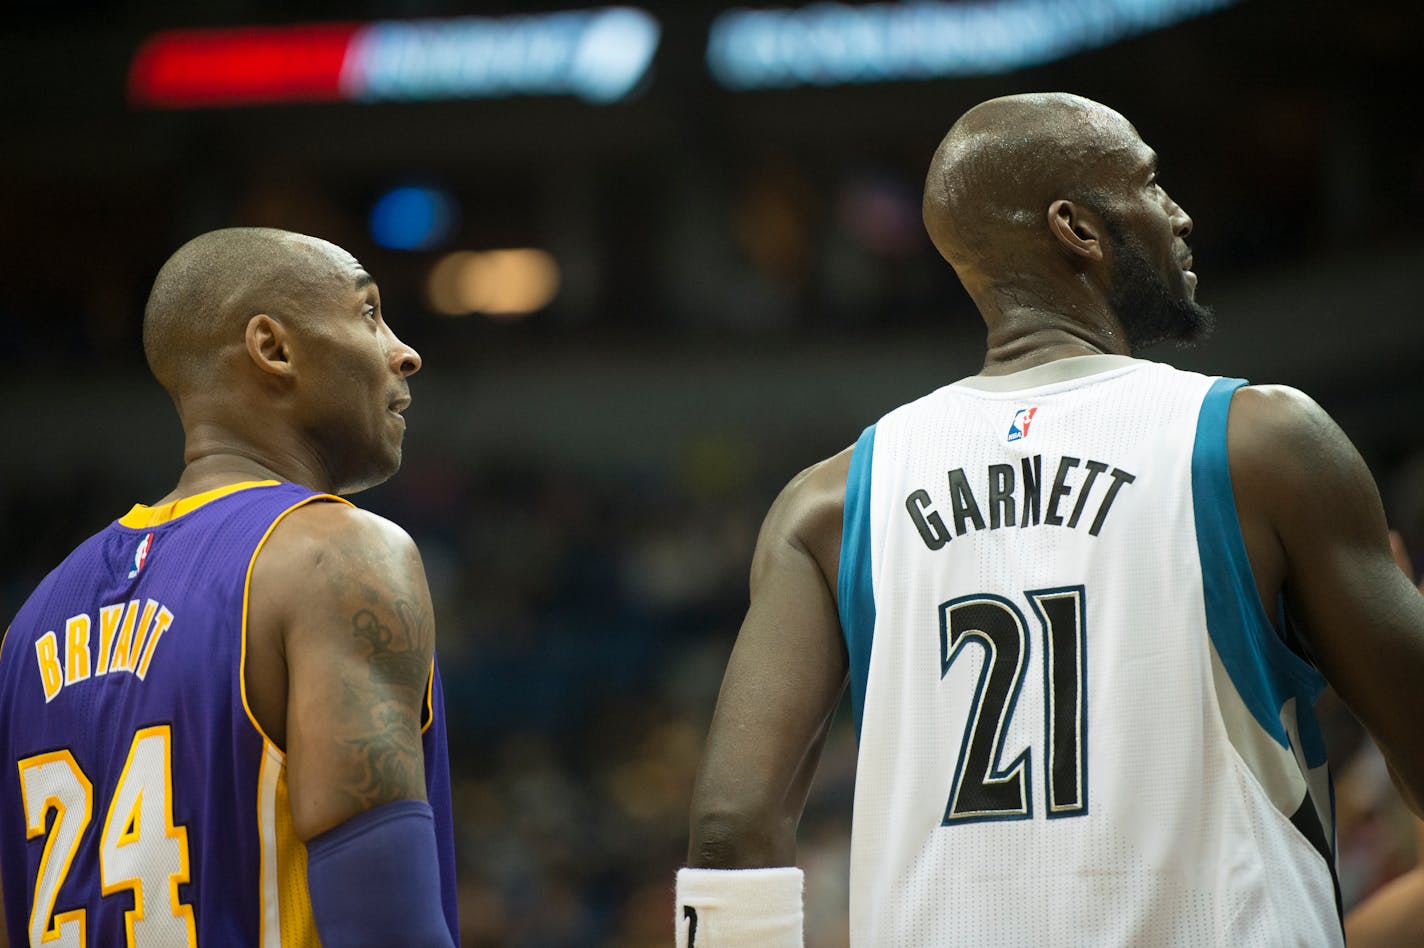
[128,7,661,108]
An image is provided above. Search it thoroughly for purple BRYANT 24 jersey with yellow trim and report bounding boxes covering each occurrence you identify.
[0,481,459,948]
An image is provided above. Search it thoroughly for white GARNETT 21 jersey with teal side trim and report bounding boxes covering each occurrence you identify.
[839,356,1343,948]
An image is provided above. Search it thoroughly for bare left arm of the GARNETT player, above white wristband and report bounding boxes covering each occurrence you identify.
[688,450,850,868]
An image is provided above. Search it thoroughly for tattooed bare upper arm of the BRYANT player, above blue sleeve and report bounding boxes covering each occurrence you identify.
[249,504,434,840]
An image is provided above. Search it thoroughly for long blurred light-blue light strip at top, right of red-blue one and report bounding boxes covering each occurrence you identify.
[706,0,1240,90]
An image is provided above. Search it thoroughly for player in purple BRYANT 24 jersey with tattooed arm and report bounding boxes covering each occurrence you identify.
[0,229,457,948]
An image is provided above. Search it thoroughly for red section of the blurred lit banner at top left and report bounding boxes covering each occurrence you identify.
[128,23,359,108]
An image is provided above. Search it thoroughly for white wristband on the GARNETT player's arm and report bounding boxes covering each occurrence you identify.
[675,865,806,948]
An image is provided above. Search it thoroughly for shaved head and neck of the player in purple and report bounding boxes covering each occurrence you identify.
[134,228,420,495]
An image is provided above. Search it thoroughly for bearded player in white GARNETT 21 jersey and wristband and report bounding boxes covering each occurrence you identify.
[676,94,1424,948]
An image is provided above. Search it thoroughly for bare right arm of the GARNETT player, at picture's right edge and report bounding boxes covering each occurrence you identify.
[1227,387,1424,814]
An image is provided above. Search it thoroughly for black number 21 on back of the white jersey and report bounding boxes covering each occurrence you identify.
[940,586,1088,826]
